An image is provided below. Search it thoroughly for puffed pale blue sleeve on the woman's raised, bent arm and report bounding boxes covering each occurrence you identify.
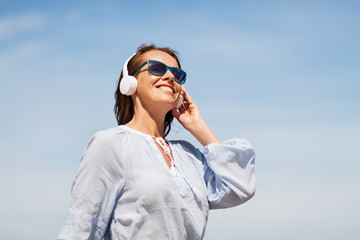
[203,139,256,209]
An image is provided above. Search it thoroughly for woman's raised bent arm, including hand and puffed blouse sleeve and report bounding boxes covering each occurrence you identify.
[172,88,256,209]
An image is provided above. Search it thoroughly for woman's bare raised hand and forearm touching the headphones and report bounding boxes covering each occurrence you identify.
[171,87,220,146]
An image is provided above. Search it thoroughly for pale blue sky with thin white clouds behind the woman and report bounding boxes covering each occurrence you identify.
[0,0,360,240]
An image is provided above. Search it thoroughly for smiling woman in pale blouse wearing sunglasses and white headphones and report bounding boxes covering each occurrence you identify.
[58,45,255,239]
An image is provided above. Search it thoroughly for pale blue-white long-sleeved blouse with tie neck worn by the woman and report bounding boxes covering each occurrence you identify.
[58,125,256,240]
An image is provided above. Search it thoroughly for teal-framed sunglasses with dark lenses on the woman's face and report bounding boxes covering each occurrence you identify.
[130,60,186,84]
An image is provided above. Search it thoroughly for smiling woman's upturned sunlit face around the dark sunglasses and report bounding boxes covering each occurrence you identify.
[136,50,182,111]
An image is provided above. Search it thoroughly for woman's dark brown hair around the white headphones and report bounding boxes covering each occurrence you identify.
[114,44,181,137]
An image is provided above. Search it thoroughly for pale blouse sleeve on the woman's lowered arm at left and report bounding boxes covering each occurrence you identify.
[57,132,124,240]
